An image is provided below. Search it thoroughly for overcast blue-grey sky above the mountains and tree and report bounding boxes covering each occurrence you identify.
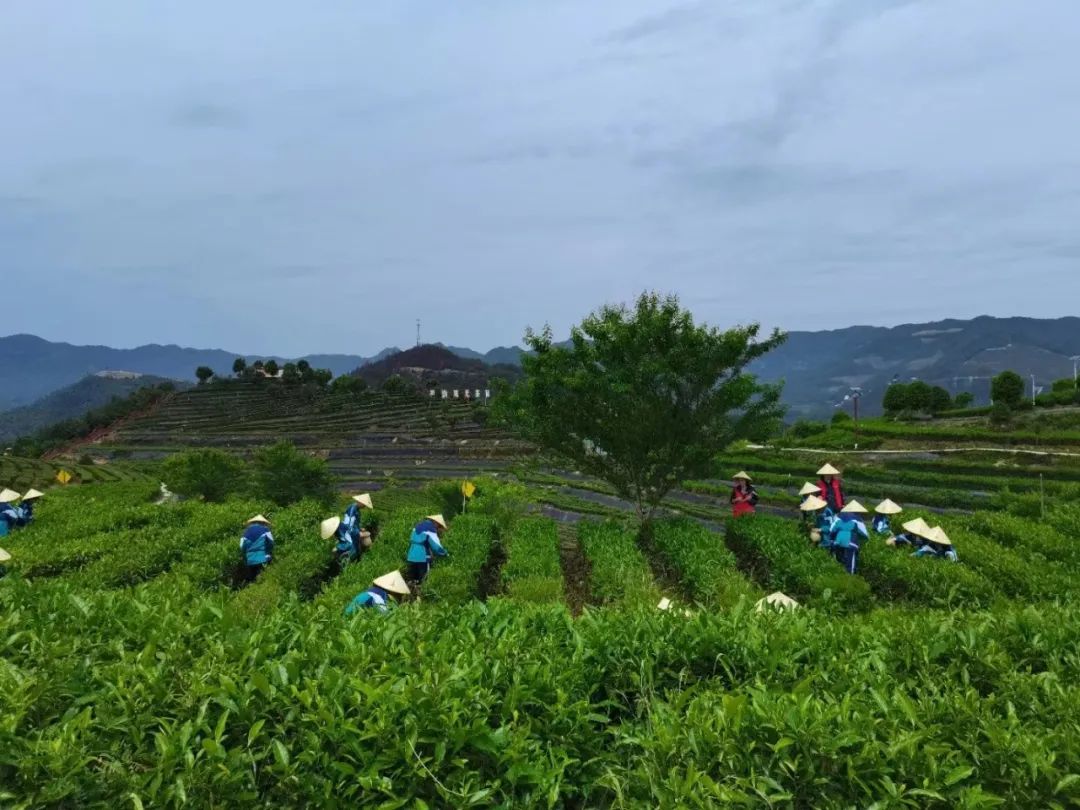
[0,0,1080,354]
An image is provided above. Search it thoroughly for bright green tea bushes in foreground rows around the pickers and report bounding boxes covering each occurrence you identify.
[0,480,1080,808]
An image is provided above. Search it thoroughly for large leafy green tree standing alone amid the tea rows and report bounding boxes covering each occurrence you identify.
[494,293,784,525]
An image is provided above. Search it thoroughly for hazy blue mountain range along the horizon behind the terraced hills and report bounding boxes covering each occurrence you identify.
[0,316,1080,418]
